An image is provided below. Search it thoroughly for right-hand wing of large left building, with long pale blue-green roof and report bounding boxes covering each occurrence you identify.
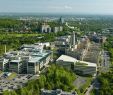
[27,51,51,74]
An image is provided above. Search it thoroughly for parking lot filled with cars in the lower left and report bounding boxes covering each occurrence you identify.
[0,73,34,93]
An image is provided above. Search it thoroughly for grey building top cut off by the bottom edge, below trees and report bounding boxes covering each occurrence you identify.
[41,89,78,95]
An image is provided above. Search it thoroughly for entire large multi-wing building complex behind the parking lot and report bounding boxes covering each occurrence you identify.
[0,45,52,74]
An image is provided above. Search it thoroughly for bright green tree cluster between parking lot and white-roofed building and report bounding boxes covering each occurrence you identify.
[3,65,76,95]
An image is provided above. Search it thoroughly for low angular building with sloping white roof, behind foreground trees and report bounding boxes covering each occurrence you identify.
[56,55,97,75]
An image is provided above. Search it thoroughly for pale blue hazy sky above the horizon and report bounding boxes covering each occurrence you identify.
[0,0,113,14]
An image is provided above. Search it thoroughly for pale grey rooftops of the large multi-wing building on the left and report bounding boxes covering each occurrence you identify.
[4,45,51,62]
